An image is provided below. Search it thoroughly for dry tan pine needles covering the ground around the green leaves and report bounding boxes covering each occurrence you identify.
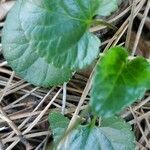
[0,0,150,150]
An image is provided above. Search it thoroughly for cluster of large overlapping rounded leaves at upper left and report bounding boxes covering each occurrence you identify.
[2,0,121,87]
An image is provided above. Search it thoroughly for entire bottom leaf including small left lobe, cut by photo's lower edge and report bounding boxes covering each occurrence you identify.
[49,112,135,150]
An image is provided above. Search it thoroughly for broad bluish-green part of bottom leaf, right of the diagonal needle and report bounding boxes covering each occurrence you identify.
[57,117,135,150]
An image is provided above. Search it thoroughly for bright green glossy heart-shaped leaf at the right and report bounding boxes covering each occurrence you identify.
[90,47,150,117]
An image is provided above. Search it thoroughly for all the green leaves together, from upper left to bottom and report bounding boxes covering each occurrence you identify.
[2,0,150,150]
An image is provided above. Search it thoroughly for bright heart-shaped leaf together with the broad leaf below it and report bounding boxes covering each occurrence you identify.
[49,47,150,150]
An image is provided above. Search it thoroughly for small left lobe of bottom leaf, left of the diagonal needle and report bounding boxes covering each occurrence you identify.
[48,112,70,142]
